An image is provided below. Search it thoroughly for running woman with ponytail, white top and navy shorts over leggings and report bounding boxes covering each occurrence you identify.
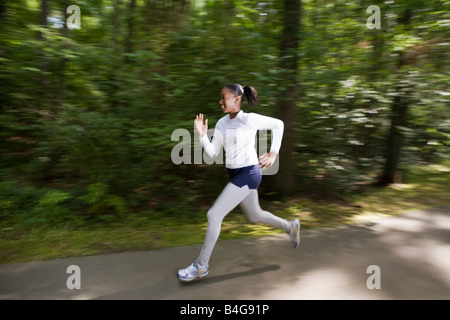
[178,84,300,281]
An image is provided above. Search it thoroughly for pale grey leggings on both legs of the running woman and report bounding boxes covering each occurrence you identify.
[197,182,290,266]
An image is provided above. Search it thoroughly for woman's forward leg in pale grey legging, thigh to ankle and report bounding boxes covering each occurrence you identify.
[197,182,251,266]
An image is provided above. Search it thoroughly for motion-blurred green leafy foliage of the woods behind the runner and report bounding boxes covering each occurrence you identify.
[0,0,450,224]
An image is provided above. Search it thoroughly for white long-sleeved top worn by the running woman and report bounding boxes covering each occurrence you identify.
[200,110,284,169]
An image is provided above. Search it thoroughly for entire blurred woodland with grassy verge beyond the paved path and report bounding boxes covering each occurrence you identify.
[0,0,450,262]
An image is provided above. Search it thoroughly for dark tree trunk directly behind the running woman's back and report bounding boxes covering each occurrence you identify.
[273,0,301,195]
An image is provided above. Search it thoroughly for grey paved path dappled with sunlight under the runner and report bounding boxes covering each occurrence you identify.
[0,207,450,300]
